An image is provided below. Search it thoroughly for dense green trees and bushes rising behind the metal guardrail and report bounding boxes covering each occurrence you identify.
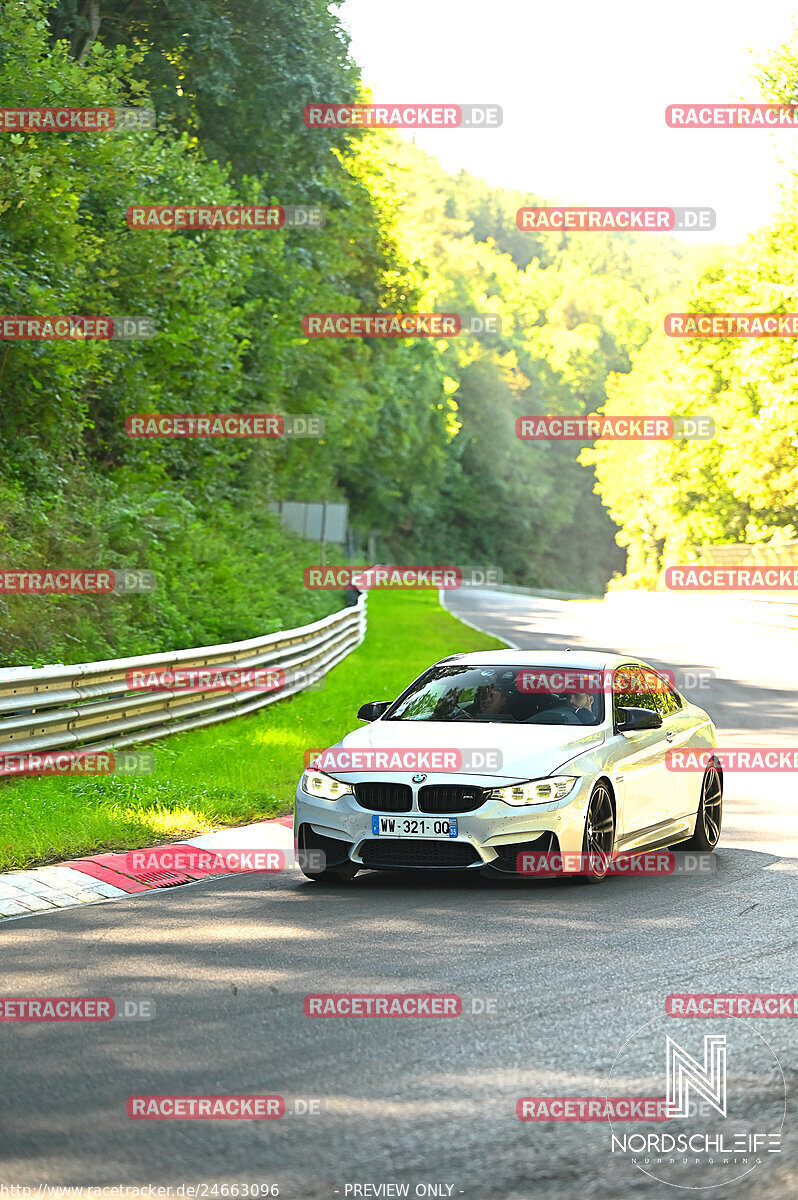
[0,0,700,662]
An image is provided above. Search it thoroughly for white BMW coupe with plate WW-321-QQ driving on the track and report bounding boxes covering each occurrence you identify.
[294,649,724,881]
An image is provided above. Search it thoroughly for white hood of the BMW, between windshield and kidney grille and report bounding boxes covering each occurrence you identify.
[312,721,605,782]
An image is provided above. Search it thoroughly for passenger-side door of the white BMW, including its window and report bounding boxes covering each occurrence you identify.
[612,662,672,848]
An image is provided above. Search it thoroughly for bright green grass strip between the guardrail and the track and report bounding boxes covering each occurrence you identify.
[0,592,504,870]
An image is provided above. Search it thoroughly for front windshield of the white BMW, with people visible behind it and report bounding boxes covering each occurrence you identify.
[383,664,604,725]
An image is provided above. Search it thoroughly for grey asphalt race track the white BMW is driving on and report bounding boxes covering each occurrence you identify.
[0,592,798,1200]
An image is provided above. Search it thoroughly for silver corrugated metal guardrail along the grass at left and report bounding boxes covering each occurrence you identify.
[0,594,366,755]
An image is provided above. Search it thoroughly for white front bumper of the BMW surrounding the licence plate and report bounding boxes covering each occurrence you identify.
[294,774,590,871]
